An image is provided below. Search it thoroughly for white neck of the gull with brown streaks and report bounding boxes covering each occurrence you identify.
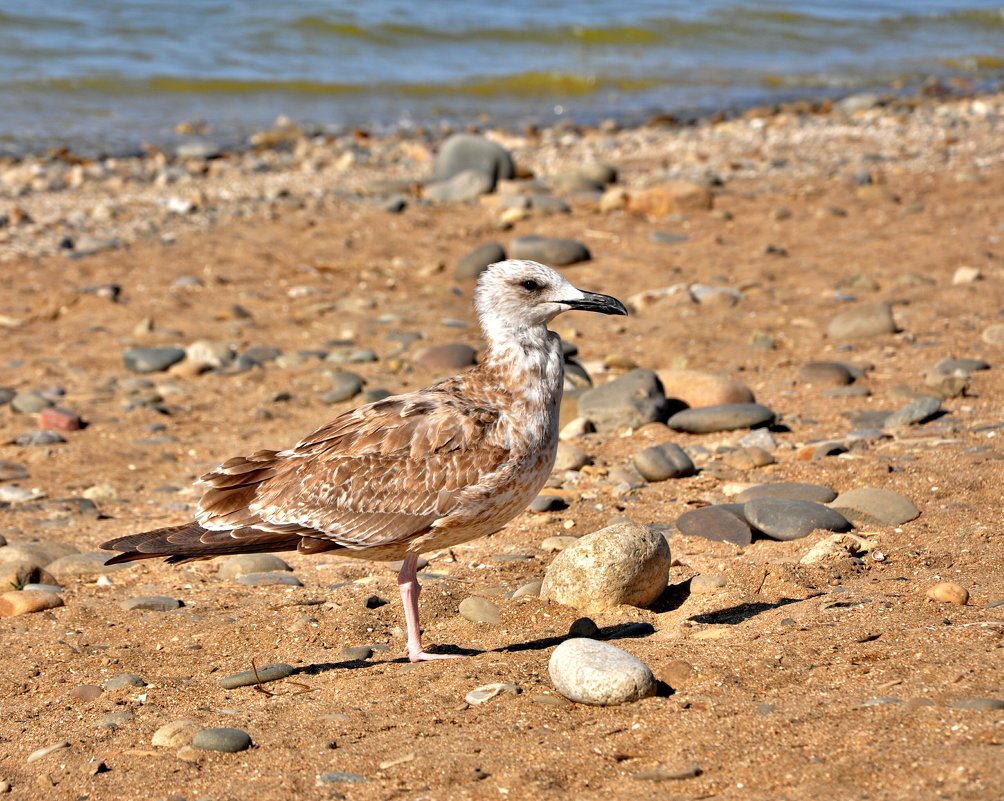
[482,325,564,414]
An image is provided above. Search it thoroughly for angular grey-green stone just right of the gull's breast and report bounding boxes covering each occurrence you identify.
[578,368,670,433]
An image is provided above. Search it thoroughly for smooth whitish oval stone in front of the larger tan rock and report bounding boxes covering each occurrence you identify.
[547,637,656,706]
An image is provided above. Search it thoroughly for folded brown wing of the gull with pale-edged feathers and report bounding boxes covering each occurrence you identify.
[198,391,508,548]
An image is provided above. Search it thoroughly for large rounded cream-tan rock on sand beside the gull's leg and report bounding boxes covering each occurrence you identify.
[540,522,671,613]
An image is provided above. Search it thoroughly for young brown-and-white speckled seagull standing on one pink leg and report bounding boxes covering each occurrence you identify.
[107,259,628,662]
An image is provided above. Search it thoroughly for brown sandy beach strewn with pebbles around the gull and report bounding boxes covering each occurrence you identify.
[0,94,1004,801]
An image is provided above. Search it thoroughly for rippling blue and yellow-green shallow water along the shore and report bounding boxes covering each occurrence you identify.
[0,0,1004,151]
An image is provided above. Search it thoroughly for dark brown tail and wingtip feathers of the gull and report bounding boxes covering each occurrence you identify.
[101,523,300,564]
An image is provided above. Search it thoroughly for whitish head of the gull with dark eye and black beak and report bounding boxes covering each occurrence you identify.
[474,259,628,338]
